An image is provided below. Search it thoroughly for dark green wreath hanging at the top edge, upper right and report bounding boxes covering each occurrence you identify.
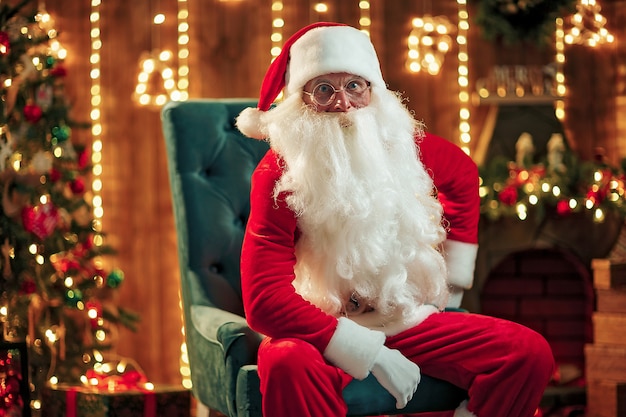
[476,0,576,46]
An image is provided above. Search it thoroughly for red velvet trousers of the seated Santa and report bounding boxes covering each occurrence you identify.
[258,313,554,417]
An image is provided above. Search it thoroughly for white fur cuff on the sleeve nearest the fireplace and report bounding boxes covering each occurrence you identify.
[443,240,478,289]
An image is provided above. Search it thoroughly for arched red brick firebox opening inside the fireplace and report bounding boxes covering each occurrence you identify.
[481,249,594,371]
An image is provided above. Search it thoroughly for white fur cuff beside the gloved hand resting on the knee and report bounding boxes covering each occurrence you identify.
[324,317,385,379]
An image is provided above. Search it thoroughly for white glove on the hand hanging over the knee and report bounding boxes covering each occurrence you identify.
[371,346,422,409]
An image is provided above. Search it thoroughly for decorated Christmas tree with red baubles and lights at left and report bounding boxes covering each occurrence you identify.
[0,0,137,415]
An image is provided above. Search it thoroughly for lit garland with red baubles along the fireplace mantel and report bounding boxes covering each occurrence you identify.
[480,152,626,223]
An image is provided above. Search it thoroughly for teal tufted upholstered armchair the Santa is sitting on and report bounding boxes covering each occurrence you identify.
[162,99,466,417]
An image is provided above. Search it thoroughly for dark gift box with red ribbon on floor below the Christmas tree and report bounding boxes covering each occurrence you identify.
[41,384,191,417]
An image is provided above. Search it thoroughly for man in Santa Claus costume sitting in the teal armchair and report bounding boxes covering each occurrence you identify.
[237,23,553,417]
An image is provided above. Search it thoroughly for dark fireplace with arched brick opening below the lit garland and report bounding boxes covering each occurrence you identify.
[463,208,622,382]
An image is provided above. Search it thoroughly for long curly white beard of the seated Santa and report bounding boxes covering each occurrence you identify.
[265,90,448,322]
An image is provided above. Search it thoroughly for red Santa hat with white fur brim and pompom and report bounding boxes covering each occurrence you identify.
[237,22,385,139]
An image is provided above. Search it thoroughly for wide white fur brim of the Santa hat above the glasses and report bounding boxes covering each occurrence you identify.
[285,26,385,96]
